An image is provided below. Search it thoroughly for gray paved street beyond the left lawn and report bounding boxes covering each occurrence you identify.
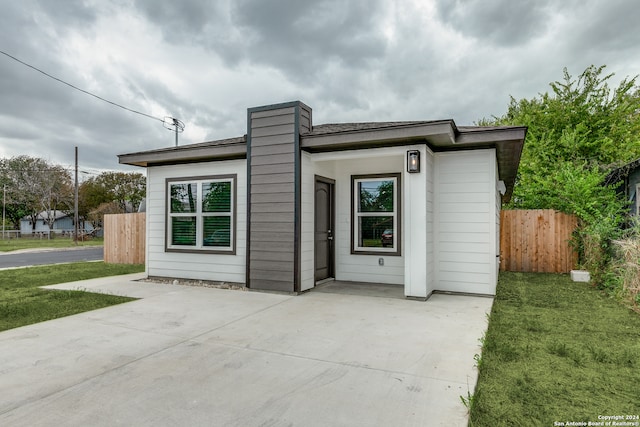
[0,246,104,269]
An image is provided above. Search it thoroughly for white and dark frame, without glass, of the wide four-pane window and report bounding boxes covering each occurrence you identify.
[165,174,237,255]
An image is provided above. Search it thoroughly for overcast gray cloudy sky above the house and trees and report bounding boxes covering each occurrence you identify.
[0,0,640,176]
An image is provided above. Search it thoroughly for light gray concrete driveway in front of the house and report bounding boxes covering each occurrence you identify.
[0,275,492,427]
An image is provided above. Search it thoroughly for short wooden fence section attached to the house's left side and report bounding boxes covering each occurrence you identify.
[104,213,146,264]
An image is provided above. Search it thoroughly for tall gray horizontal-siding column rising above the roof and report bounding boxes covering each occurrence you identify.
[246,101,311,292]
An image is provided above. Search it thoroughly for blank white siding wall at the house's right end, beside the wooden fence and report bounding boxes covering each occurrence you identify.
[435,149,496,295]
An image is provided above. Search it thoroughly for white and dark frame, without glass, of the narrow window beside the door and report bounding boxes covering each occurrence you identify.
[351,173,402,256]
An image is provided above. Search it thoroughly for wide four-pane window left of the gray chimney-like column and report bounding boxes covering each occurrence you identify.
[166,175,236,253]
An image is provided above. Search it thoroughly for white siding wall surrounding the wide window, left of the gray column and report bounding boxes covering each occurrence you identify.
[147,160,247,283]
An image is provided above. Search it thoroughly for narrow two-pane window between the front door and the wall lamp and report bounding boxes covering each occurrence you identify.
[351,174,400,255]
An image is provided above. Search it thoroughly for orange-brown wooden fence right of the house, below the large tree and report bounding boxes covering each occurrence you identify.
[500,209,578,273]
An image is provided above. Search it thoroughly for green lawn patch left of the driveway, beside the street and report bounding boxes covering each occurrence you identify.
[0,262,144,331]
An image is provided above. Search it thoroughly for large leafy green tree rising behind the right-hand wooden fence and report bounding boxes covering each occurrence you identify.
[481,66,640,222]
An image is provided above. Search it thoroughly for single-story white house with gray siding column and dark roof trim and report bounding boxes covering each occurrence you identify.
[119,101,526,298]
